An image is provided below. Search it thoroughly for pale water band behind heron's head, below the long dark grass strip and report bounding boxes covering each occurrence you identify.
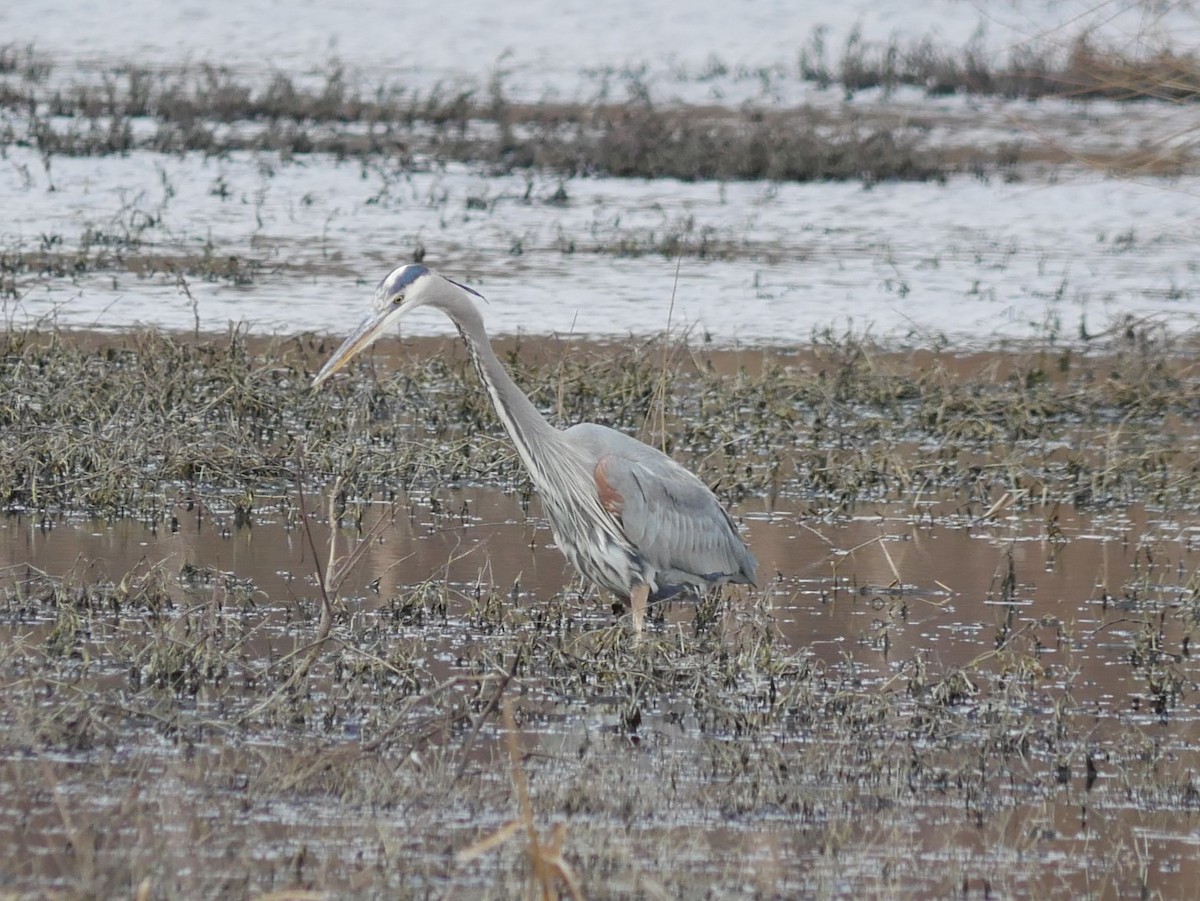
[0,149,1200,346]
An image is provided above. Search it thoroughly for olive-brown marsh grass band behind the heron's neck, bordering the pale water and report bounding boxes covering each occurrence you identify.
[7,329,1200,527]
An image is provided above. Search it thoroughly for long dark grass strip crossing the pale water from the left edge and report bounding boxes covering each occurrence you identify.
[0,59,944,181]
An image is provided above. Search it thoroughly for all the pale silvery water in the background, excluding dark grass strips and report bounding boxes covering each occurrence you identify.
[7,0,1200,346]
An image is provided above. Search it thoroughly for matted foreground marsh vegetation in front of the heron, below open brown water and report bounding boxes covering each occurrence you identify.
[0,482,1200,897]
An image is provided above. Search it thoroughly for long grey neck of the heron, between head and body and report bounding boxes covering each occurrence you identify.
[450,301,563,485]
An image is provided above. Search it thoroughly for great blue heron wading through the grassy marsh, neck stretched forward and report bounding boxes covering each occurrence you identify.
[313,265,757,630]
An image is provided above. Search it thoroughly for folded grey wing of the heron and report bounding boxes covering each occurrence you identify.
[585,439,756,583]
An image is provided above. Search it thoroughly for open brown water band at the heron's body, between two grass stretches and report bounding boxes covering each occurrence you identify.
[0,487,1200,695]
